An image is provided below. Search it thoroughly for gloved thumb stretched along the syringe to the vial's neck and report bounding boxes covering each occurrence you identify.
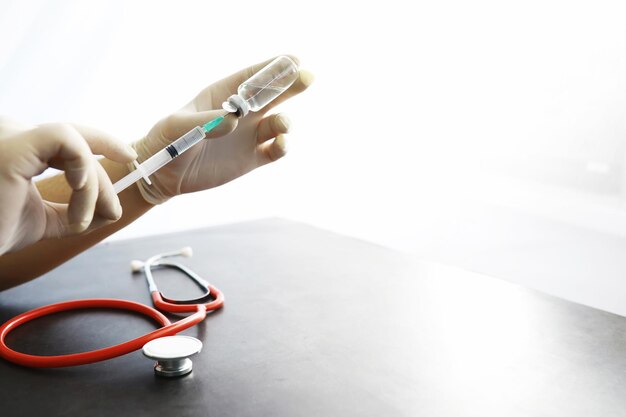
[161,110,237,142]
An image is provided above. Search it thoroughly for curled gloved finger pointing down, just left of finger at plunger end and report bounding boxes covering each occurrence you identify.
[66,158,99,233]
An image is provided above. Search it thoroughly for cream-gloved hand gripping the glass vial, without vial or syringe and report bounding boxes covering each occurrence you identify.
[133,57,313,204]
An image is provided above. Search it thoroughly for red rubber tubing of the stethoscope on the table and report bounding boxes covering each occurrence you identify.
[0,285,224,368]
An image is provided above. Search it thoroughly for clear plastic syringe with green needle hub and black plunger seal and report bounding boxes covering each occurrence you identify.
[113,116,225,194]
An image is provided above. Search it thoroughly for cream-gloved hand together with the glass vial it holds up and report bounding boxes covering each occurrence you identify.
[133,57,313,204]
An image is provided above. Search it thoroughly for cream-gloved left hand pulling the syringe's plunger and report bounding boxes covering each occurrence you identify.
[0,119,136,254]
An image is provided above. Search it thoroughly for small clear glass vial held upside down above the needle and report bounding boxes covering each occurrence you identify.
[222,56,298,117]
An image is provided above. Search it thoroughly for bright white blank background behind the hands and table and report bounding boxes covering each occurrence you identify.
[0,0,626,314]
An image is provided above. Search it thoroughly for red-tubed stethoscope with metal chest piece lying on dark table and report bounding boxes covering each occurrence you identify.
[0,247,224,376]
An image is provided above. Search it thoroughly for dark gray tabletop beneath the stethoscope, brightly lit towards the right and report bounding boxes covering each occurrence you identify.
[0,219,626,417]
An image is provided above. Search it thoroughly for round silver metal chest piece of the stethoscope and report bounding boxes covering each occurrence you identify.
[143,336,202,377]
